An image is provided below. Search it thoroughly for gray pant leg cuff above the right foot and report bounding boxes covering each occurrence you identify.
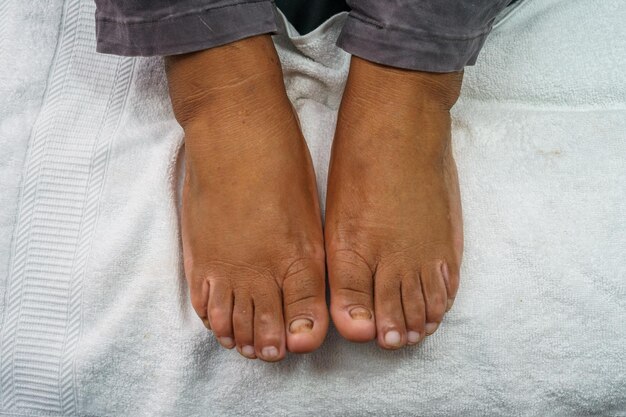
[337,0,511,72]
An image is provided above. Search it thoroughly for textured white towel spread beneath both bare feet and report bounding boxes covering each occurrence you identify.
[0,0,626,416]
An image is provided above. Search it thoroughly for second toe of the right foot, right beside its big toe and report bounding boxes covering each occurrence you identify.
[374,267,406,349]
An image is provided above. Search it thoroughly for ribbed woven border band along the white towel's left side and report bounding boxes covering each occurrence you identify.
[0,0,134,415]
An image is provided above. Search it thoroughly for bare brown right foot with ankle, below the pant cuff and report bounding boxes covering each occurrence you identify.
[325,57,463,349]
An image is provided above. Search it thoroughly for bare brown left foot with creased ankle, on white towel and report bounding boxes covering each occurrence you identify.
[166,35,328,361]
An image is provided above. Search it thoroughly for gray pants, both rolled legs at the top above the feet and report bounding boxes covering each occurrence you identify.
[95,0,512,72]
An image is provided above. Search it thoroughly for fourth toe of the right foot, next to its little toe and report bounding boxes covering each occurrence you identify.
[420,261,447,335]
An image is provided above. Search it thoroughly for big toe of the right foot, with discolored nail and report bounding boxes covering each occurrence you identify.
[328,252,376,342]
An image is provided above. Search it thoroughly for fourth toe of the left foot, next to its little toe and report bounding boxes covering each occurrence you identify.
[207,280,235,349]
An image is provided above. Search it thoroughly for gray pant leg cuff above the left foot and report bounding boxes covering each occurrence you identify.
[95,0,277,56]
